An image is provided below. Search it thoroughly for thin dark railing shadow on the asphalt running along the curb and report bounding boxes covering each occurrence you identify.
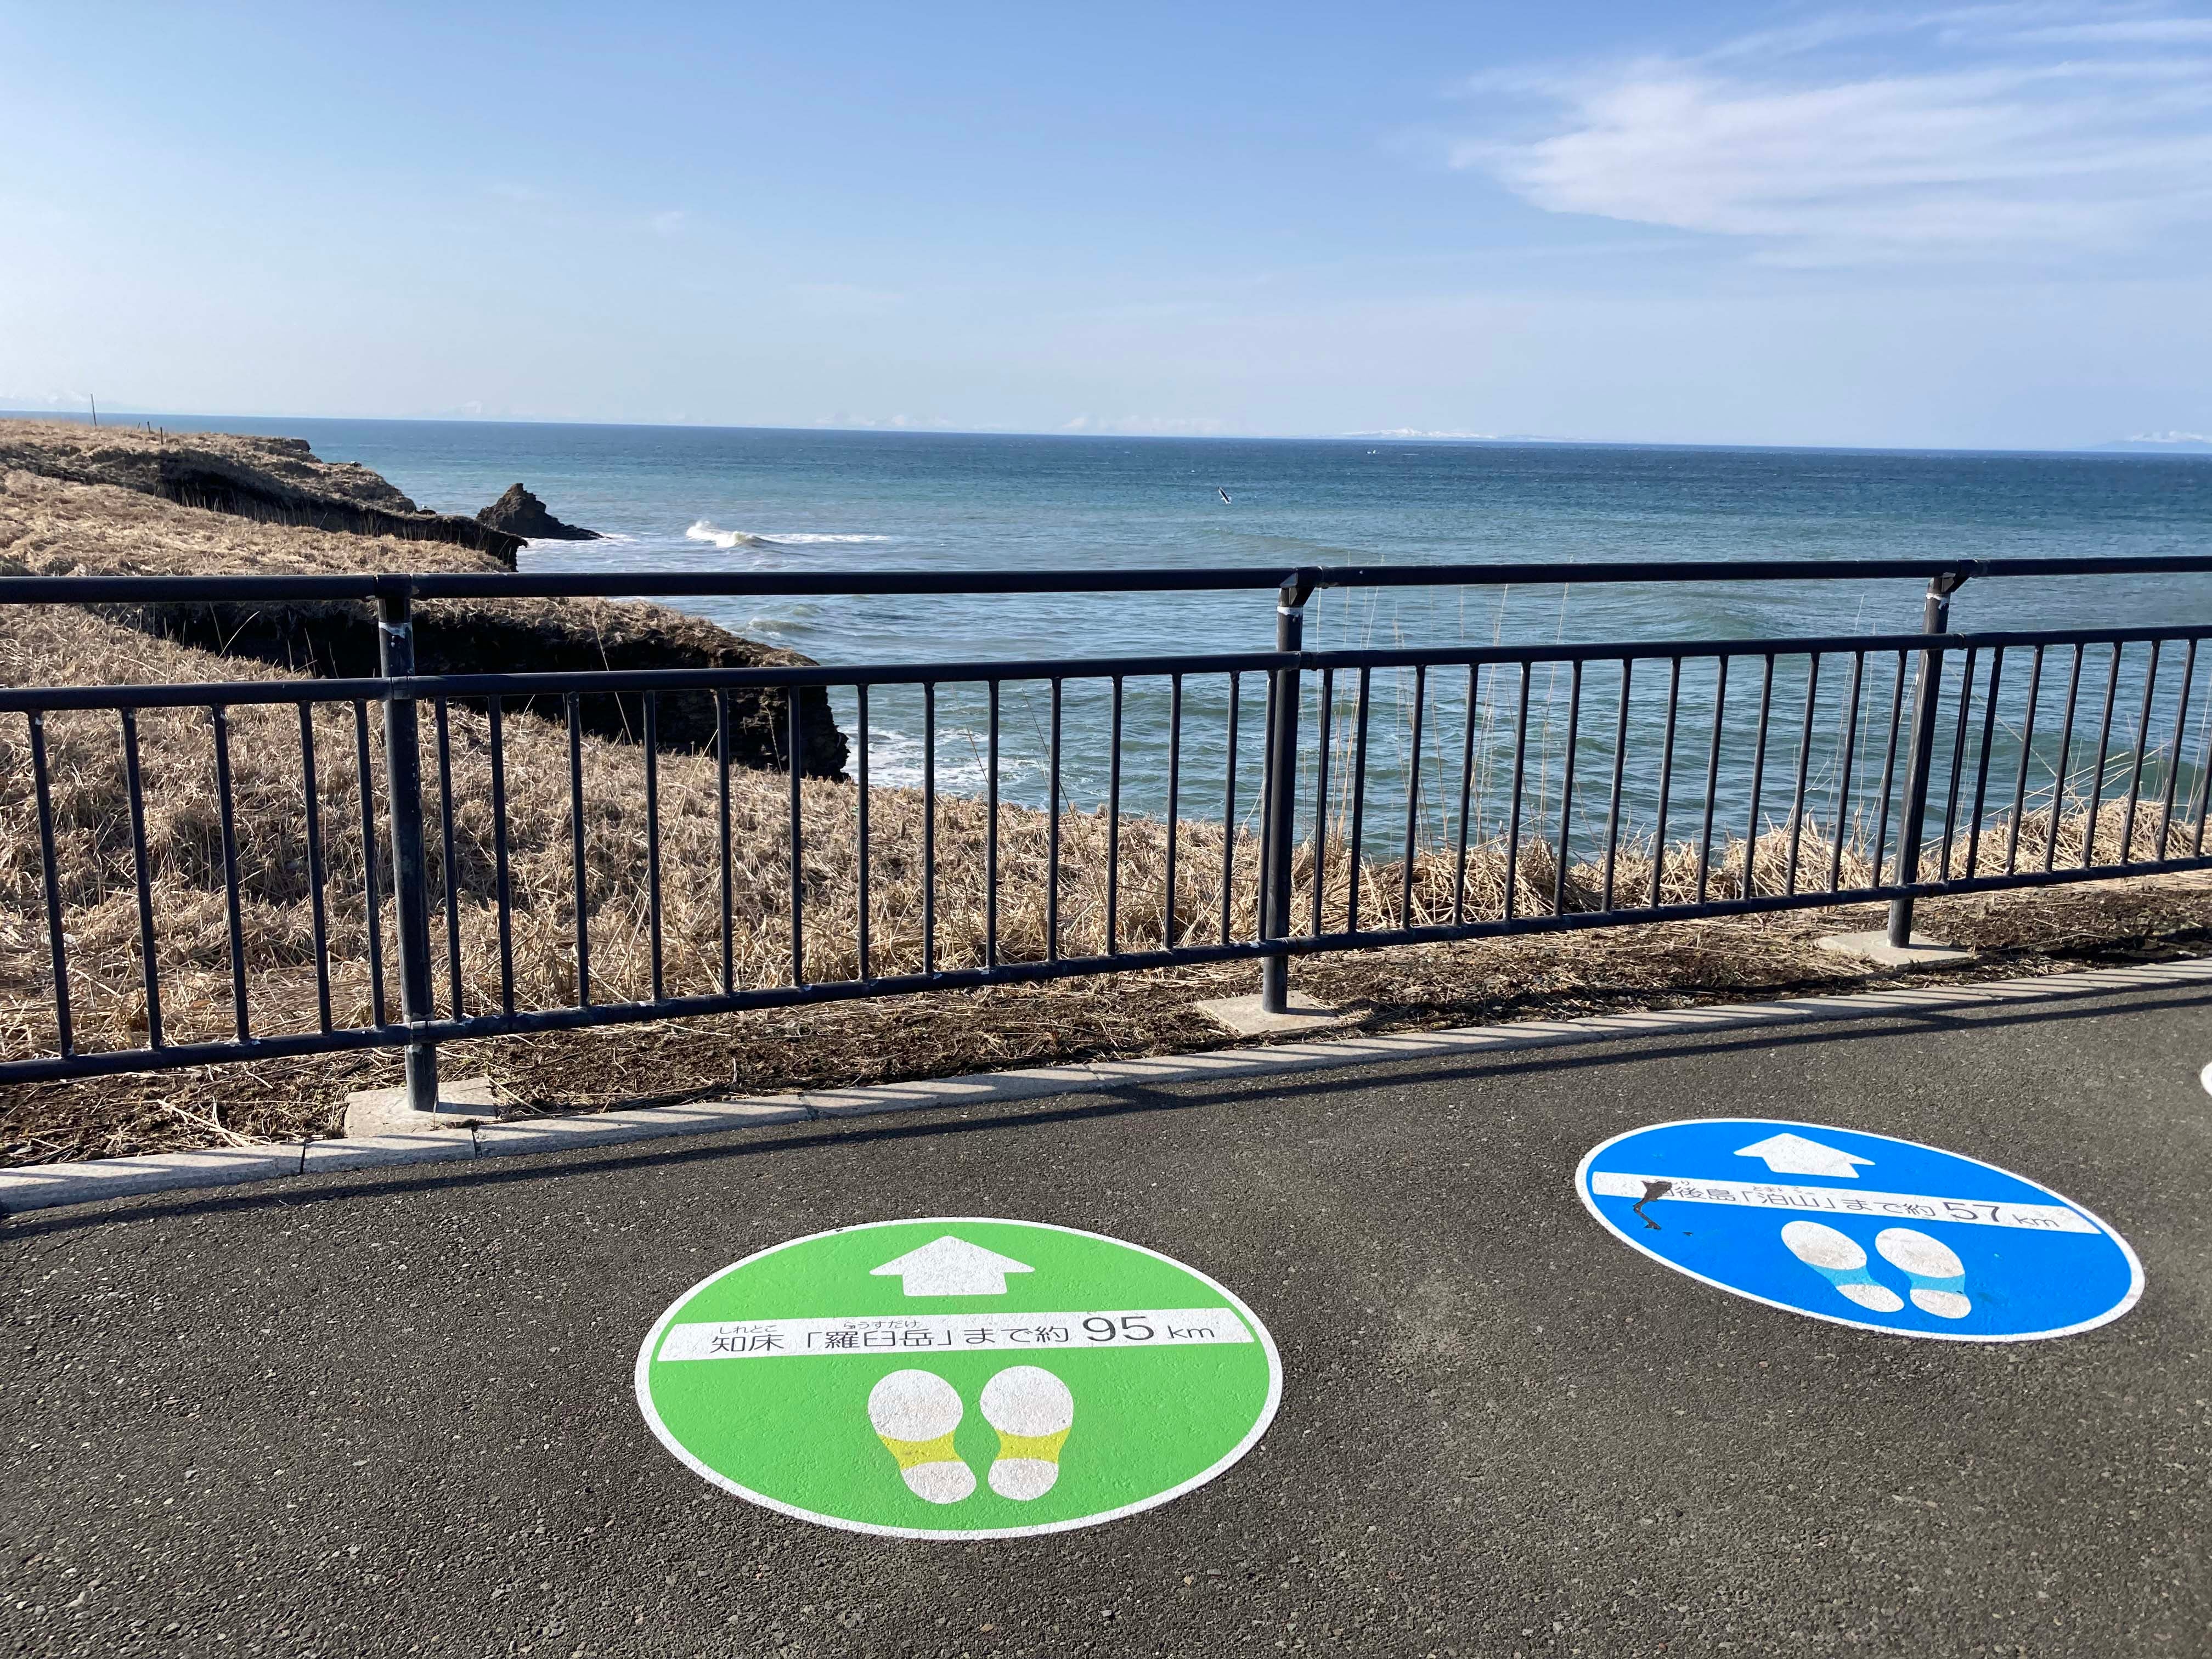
[0,989,2212,1239]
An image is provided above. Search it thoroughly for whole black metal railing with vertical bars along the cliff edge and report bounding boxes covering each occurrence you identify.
[0,557,2212,1106]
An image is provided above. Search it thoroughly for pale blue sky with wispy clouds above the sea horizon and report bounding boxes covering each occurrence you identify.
[0,0,2212,449]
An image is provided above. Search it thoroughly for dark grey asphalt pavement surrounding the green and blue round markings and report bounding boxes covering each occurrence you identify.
[0,989,2212,1659]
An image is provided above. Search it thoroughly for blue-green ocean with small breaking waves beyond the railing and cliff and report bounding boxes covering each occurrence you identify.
[133,416,2212,858]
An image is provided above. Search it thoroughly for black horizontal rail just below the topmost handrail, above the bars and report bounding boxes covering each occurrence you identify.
[0,624,2212,714]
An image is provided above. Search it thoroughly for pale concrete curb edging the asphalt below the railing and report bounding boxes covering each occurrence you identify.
[0,958,2212,1215]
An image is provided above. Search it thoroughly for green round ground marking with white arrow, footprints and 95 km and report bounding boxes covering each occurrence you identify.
[637,1217,1283,1537]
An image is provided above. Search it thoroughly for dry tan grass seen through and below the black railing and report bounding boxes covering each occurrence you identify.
[0,608,2212,1161]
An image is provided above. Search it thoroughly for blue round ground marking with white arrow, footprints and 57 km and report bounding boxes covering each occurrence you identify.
[1575,1117,2143,1342]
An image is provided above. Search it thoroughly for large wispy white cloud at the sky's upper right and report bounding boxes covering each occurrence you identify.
[1451,4,2212,263]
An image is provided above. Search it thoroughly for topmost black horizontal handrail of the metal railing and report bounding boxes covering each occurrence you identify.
[13,553,2212,604]
